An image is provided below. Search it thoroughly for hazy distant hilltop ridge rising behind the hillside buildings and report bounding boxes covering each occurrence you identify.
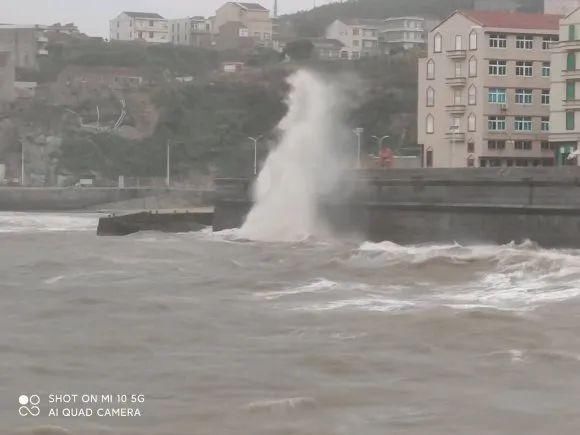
[282,0,542,37]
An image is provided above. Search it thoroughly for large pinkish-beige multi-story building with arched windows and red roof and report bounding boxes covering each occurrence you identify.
[418,11,560,167]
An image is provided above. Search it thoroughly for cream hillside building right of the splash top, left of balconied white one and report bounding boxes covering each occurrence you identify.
[326,18,385,59]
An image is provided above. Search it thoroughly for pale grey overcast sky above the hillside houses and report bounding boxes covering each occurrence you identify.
[0,0,330,36]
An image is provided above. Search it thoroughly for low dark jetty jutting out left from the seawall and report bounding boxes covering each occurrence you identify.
[97,212,213,236]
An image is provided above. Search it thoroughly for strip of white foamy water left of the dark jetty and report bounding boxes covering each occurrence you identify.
[0,213,99,233]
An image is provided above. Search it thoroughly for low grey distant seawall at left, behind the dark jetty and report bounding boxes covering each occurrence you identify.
[0,187,214,211]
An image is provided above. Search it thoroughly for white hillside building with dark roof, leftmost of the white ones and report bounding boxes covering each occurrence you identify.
[110,12,169,44]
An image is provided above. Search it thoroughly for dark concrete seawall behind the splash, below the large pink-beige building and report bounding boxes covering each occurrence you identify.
[214,167,580,248]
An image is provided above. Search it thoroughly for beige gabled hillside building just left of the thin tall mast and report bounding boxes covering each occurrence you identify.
[212,2,274,47]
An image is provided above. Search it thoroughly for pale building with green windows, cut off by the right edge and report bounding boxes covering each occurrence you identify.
[550,9,580,165]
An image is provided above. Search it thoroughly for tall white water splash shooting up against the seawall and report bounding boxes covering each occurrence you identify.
[240,71,346,241]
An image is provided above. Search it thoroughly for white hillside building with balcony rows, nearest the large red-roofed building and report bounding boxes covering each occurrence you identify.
[381,17,426,53]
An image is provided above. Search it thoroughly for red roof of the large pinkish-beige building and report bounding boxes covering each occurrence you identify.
[460,11,562,30]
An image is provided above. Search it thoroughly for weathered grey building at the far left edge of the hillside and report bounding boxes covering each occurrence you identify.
[0,24,48,70]
